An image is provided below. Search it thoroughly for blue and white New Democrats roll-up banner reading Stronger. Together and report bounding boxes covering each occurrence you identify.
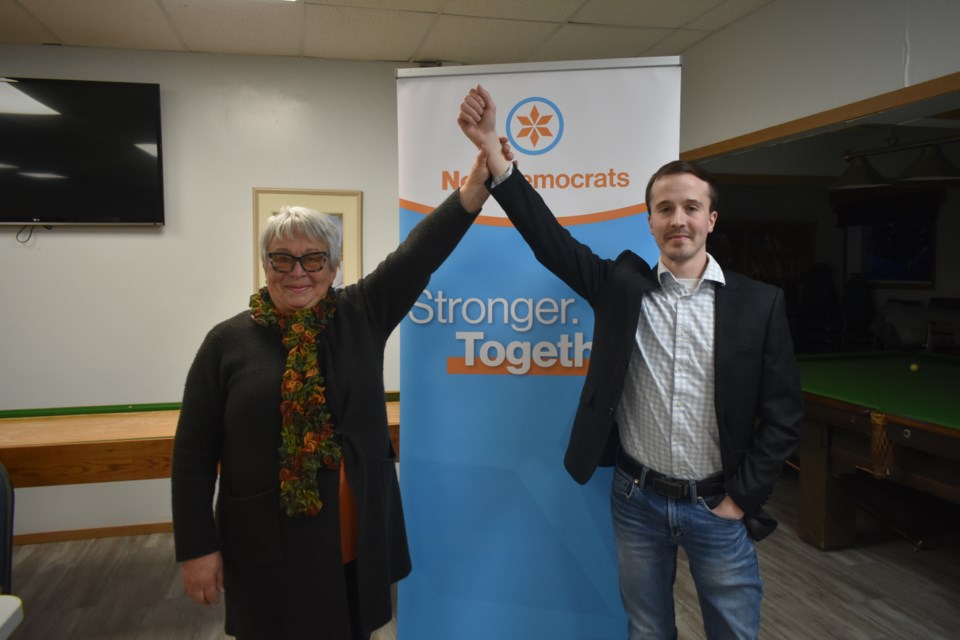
[397,57,680,640]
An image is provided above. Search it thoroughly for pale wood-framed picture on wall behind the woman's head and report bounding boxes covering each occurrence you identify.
[253,189,363,291]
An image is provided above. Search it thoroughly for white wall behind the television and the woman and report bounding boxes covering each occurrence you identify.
[0,46,422,534]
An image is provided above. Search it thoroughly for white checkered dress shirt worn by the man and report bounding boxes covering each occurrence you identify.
[616,255,725,480]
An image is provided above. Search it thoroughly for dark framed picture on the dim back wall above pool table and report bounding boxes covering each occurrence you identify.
[861,216,937,288]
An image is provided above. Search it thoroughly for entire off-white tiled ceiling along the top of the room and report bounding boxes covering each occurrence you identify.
[0,0,772,64]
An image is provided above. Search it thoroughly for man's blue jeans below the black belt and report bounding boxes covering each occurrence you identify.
[610,468,763,640]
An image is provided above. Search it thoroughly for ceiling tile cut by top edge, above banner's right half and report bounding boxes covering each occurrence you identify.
[572,0,723,28]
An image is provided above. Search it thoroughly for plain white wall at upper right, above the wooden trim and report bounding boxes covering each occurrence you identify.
[680,0,960,150]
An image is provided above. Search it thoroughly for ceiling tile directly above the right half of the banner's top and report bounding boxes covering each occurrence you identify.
[533,24,670,61]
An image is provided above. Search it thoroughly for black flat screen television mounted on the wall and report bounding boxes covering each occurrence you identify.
[0,77,164,226]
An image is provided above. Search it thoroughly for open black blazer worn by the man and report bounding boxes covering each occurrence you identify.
[492,170,803,539]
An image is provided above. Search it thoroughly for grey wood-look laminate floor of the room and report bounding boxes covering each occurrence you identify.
[11,472,960,640]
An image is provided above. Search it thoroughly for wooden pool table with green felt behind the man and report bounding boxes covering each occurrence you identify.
[797,351,960,549]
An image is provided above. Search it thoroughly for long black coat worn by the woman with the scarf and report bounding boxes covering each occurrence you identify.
[172,193,478,640]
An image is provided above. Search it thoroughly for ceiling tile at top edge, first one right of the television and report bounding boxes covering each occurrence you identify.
[160,0,304,56]
